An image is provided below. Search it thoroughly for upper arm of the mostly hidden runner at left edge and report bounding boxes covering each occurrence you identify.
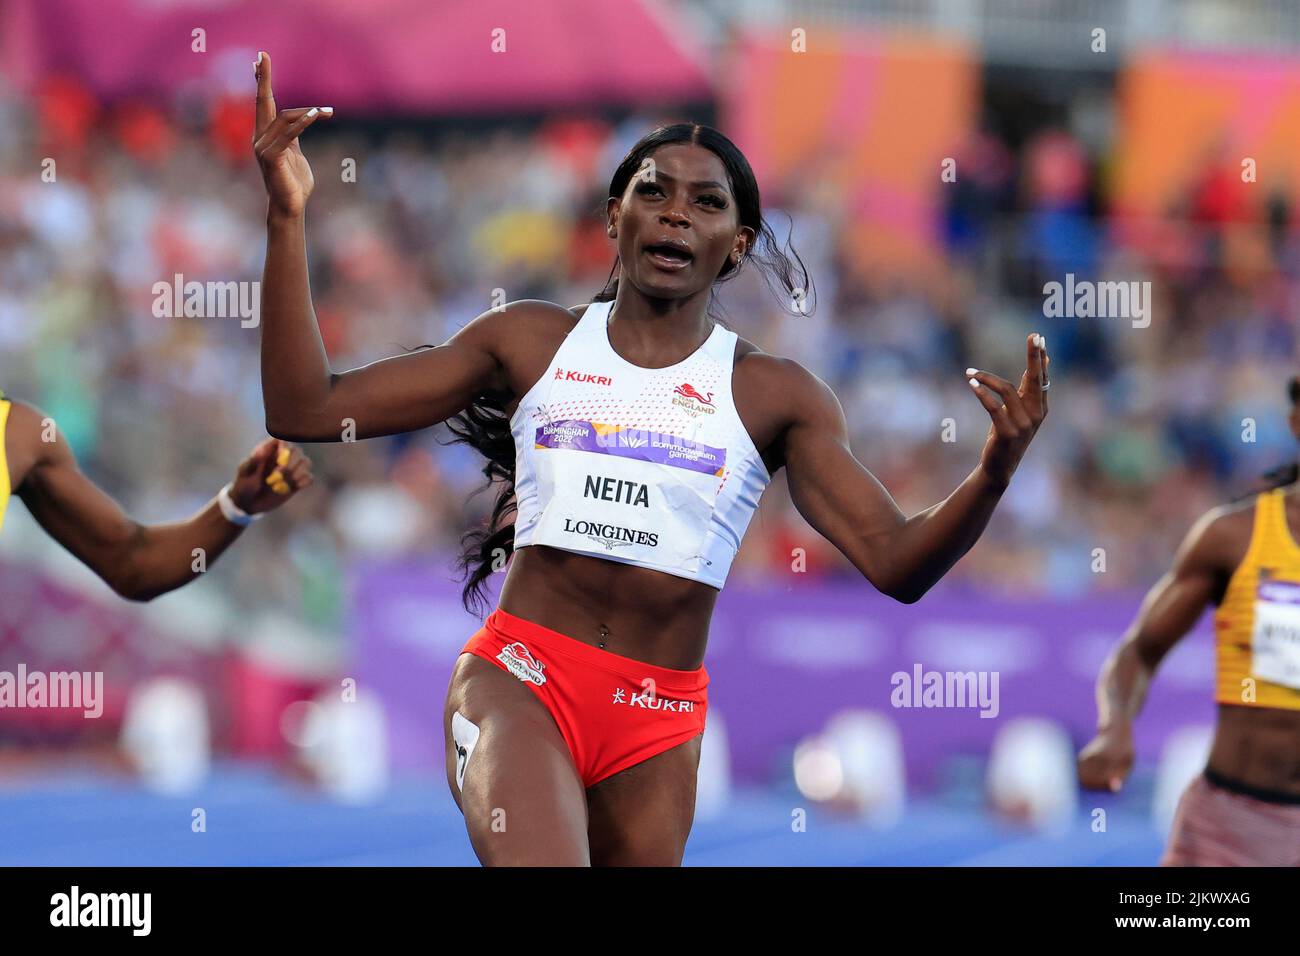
[9,402,140,581]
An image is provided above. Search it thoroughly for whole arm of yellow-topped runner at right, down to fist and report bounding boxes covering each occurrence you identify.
[1079,509,1226,791]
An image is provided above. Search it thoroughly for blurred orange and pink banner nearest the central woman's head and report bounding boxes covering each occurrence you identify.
[720,27,979,282]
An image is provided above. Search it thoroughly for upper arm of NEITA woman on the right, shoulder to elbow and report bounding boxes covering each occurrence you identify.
[771,359,907,588]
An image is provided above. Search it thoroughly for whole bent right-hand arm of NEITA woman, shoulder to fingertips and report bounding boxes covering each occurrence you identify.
[783,336,1047,604]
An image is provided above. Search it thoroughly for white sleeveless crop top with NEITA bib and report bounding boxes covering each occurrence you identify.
[510,302,771,588]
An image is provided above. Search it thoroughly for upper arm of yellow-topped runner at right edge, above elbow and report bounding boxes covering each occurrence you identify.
[1128,509,1235,669]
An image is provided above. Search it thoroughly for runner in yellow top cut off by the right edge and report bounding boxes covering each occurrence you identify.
[1079,378,1300,866]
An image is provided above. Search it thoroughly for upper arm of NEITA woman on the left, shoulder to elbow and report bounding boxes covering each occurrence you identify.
[267,300,561,441]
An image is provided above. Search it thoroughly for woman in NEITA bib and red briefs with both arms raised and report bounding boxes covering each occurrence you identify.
[255,55,1047,865]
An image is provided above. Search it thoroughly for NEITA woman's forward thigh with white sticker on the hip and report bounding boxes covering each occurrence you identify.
[443,654,590,866]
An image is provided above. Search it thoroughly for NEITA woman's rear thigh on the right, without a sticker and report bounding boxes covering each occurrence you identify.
[586,735,703,866]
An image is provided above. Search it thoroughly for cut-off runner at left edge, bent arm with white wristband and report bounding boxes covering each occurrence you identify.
[0,392,312,601]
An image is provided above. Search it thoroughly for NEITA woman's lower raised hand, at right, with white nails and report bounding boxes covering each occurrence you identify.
[966,332,1050,488]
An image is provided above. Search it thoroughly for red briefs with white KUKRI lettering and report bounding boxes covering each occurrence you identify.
[462,607,709,787]
